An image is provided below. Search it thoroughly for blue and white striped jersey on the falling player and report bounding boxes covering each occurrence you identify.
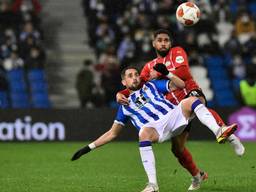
[115,80,174,130]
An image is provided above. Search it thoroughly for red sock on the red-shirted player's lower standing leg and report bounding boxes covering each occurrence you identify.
[175,148,199,176]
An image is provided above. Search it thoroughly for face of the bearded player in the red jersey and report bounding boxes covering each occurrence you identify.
[153,33,171,57]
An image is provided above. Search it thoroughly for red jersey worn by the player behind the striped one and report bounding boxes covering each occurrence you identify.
[140,47,200,104]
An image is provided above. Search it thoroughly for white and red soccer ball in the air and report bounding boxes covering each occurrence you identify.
[176,2,200,26]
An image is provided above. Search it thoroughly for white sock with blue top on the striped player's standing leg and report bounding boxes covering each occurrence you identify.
[139,141,157,184]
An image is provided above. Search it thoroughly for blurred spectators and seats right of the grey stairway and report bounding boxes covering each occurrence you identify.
[77,0,256,107]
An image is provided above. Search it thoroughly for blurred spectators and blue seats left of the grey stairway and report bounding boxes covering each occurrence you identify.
[0,0,50,108]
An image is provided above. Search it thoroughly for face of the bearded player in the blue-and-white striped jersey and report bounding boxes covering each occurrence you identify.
[122,69,140,91]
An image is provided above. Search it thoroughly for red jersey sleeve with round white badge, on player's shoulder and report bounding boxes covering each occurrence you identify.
[171,47,188,68]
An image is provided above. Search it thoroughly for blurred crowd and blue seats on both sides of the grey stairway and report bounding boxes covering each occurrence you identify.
[0,0,256,108]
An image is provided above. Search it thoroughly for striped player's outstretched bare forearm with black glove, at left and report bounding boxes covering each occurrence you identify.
[71,123,123,161]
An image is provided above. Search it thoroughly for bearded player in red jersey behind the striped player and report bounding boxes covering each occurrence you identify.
[117,29,244,190]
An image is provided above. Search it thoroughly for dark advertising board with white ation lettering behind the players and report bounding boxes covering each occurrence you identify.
[0,107,256,142]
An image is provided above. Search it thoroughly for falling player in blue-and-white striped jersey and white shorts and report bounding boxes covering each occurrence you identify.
[72,66,236,192]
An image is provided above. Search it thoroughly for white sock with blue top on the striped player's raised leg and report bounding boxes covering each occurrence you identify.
[191,99,220,135]
